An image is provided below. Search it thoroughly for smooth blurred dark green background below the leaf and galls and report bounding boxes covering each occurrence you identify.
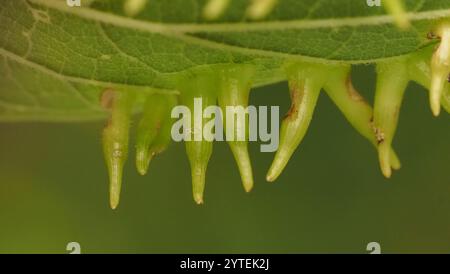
[0,66,450,253]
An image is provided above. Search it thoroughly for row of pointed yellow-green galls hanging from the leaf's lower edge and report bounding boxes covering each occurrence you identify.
[102,23,450,208]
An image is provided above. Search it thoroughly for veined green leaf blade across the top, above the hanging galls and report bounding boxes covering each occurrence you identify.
[0,0,450,121]
